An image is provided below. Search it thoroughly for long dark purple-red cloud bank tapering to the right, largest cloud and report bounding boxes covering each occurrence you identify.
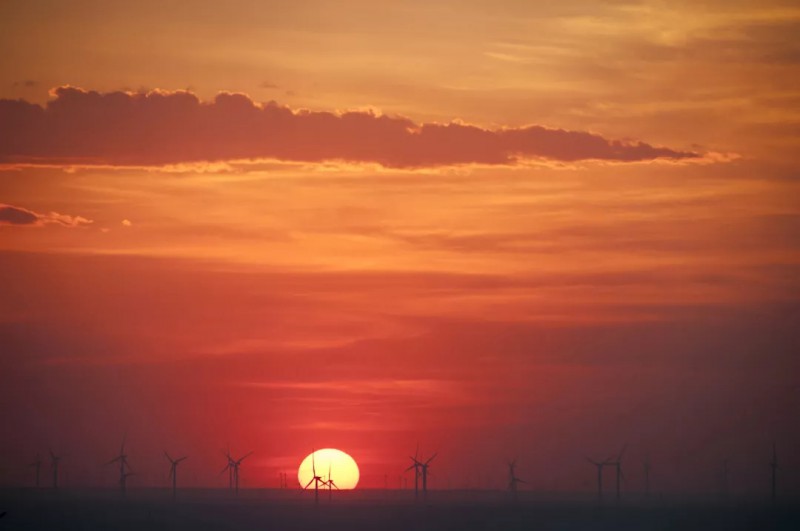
[0,86,700,168]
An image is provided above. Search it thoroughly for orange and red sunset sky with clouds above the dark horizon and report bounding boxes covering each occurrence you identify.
[0,0,800,496]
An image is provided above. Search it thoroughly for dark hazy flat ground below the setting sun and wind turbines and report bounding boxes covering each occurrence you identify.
[0,489,800,531]
